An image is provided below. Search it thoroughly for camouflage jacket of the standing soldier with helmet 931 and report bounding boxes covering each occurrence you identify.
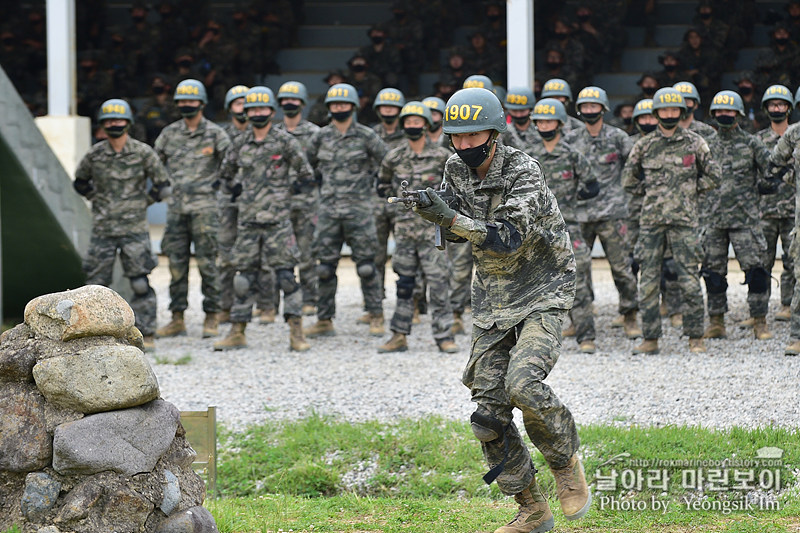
[702,128,771,228]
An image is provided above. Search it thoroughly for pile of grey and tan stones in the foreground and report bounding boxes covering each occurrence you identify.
[0,285,218,533]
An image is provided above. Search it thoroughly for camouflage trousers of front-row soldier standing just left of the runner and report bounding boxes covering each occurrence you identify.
[390,221,453,341]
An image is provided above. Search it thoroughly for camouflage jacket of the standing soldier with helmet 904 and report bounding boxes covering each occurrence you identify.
[154,118,231,214]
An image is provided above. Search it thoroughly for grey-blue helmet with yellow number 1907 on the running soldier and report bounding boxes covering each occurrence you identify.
[443,87,506,135]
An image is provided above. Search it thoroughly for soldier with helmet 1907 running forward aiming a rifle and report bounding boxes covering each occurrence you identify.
[414,88,591,533]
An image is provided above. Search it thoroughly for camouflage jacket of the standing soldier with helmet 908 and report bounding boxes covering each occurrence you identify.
[220,128,314,225]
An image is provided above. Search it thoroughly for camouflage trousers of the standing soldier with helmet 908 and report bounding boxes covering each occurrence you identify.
[231,220,303,322]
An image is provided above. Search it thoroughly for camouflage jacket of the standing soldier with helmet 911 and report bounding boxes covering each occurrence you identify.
[308,121,386,218]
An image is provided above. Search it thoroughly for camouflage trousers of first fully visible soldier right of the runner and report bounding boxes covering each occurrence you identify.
[581,218,639,314]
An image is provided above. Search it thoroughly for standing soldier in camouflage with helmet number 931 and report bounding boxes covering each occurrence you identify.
[703,91,776,340]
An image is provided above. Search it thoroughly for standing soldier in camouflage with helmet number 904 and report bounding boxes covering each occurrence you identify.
[154,79,231,337]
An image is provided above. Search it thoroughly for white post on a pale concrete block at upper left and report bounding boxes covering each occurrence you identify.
[47,0,77,116]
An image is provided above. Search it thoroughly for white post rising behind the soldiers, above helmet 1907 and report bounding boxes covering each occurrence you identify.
[506,0,535,89]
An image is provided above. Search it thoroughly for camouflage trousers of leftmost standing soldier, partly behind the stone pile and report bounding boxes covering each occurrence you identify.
[83,231,157,336]
